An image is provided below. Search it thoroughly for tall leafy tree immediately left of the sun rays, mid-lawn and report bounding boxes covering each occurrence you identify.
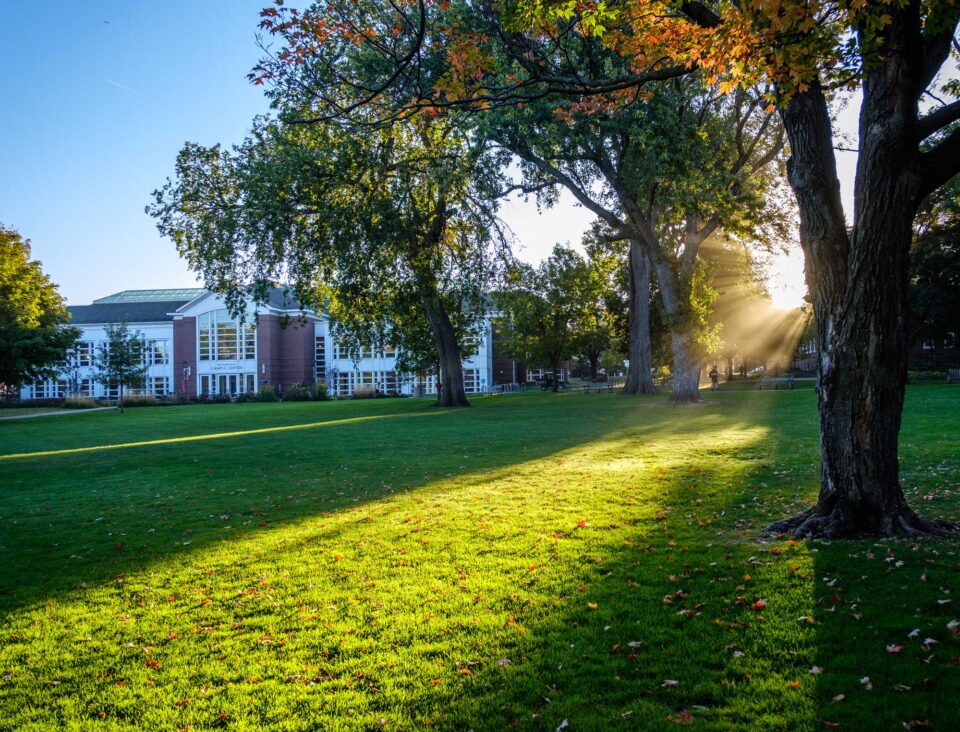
[480,79,783,403]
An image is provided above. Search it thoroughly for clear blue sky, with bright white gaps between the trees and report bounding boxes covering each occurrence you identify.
[0,0,816,304]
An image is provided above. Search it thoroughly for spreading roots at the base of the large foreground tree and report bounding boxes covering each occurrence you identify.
[762,505,960,539]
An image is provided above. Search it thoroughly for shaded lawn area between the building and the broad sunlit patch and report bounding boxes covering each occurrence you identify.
[0,396,668,612]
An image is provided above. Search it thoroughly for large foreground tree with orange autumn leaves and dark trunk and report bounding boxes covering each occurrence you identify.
[255,0,960,537]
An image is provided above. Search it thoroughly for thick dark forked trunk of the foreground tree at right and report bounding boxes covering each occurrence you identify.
[769,73,943,538]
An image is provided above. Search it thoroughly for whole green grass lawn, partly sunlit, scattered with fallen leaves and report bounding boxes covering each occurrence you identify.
[0,386,960,732]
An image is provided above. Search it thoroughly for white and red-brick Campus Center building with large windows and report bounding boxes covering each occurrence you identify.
[21,288,494,399]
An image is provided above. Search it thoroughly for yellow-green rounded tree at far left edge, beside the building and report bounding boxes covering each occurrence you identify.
[0,226,80,392]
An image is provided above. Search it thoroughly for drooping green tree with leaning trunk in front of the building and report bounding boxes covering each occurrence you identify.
[148,116,506,406]
